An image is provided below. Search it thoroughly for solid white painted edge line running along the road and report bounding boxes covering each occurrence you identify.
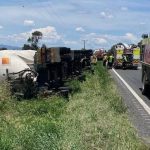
[112,69,150,115]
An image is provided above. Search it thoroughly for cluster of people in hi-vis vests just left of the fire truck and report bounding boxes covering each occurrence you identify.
[103,54,114,69]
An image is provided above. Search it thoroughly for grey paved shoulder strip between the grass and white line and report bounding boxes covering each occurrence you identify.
[110,70,150,144]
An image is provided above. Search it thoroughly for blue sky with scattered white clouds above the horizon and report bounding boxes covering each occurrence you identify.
[0,0,150,50]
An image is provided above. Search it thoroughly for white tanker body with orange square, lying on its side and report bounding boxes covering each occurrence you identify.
[0,50,36,81]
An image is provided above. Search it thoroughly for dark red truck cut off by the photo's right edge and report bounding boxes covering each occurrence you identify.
[141,34,150,94]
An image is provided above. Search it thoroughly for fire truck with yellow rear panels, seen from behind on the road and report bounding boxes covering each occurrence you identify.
[114,44,140,69]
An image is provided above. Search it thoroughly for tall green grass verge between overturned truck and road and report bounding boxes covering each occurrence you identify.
[0,63,150,150]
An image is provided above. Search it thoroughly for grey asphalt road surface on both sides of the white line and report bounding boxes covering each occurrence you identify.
[110,68,150,144]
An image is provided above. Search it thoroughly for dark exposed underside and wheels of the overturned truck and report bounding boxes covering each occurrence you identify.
[8,47,93,99]
